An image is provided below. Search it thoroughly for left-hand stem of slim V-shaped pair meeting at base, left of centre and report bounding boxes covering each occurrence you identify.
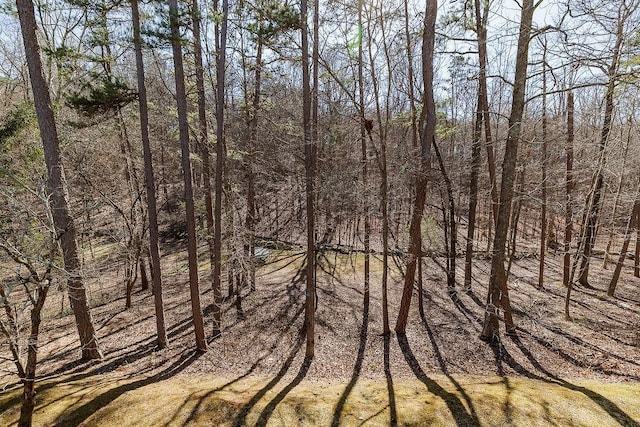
[192,0,222,337]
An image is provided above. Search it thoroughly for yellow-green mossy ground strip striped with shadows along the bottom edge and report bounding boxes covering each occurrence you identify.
[0,374,640,427]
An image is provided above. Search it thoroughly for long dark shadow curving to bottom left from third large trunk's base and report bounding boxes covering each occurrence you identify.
[55,351,201,427]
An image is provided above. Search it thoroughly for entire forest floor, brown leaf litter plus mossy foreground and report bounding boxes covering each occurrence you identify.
[0,241,640,426]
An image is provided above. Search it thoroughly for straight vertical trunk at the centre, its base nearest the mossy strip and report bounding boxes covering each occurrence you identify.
[300,0,318,358]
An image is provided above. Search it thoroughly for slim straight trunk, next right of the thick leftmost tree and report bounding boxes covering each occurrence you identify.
[131,0,168,348]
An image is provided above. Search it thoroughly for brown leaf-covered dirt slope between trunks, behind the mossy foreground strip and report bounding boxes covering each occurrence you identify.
[11,241,640,392]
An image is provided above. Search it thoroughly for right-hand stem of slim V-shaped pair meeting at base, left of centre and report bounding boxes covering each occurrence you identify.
[213,0,229,338]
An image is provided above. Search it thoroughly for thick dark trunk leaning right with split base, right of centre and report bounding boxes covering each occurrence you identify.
[480,0,539,342]
